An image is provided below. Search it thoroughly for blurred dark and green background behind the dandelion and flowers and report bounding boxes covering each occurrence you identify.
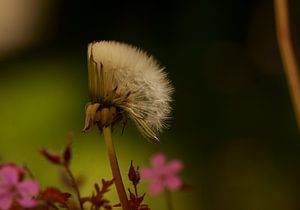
[0,0,300,210]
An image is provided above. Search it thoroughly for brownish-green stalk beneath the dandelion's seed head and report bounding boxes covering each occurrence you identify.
[103,126,130,210]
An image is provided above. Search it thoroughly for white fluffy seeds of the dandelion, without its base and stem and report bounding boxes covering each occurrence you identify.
[88,41,173,143]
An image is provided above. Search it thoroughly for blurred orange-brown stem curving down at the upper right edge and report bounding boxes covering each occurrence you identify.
[274,0,300,131]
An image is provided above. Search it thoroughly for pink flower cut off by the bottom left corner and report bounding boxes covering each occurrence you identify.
[0,165,39,210]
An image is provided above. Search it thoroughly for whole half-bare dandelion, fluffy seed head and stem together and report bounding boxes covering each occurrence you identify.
[83,41,173,210]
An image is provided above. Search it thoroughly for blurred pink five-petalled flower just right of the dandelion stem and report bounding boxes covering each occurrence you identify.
[141,153,183,196]
